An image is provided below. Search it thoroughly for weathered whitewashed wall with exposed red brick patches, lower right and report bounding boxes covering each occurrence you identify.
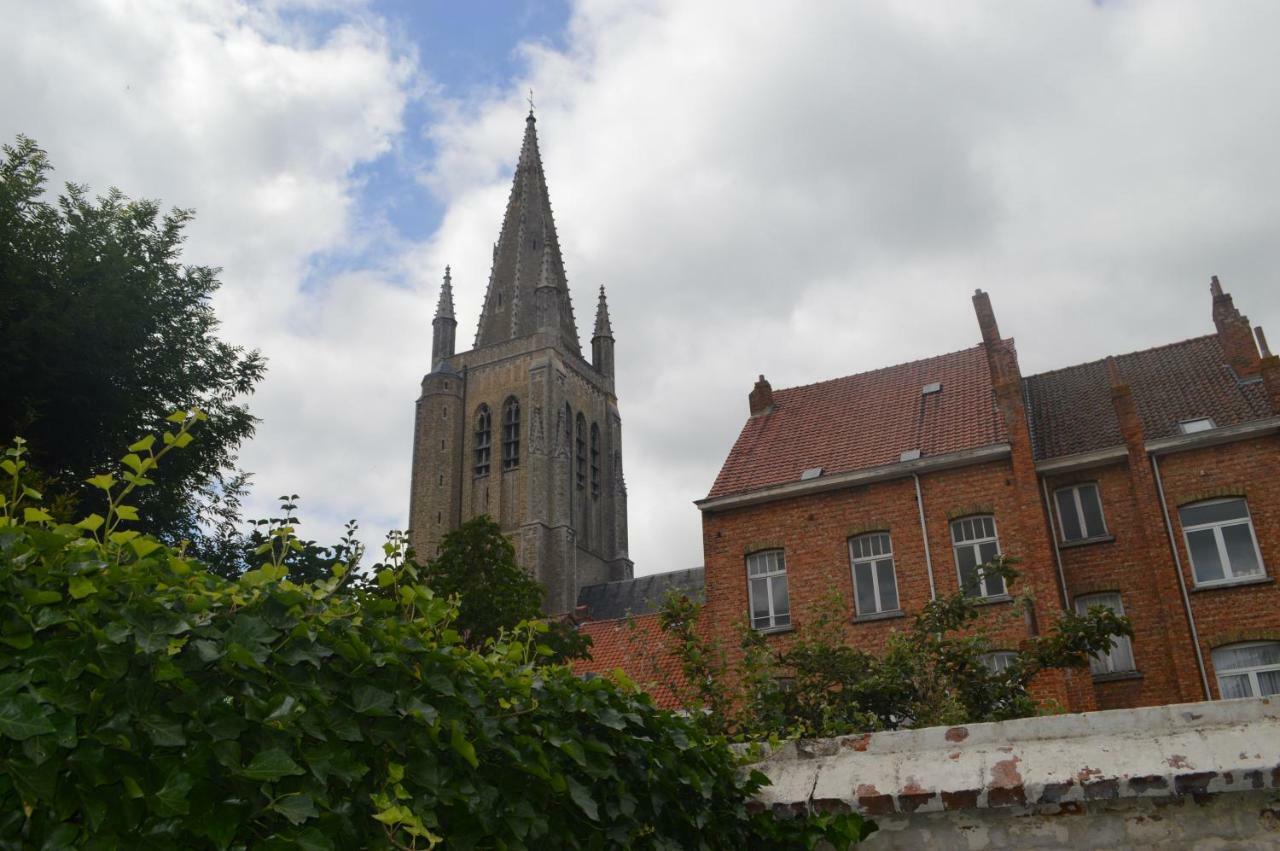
[751,697,1280,851]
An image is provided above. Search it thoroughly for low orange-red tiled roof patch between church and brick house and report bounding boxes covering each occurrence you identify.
[573,613,685,709]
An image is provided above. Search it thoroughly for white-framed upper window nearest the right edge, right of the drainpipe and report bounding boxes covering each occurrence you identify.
[1178,499,1263,585]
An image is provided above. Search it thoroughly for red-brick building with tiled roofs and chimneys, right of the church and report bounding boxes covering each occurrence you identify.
[580,278,1280,710]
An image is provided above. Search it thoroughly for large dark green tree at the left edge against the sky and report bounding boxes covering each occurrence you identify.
[0,137,264,549]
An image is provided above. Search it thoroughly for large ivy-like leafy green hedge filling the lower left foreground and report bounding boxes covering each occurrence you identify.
[0,415,869,848]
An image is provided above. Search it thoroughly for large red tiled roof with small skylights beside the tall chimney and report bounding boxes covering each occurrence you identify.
[708,346,1007,498]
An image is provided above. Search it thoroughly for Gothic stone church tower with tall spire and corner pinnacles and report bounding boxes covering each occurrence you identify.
[410,111,631,614]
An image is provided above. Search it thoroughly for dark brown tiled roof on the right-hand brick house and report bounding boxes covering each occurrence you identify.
[1023,334,1271,459]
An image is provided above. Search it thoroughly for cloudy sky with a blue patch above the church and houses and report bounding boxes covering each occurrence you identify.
[0,0,1280,573]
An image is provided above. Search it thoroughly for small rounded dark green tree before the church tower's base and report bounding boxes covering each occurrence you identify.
[426,514,591,658]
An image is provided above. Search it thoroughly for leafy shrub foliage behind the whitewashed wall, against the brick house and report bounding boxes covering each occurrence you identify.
[650,557,1132,738]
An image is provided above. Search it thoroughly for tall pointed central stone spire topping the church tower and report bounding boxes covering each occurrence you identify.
[475,110,581,354]
